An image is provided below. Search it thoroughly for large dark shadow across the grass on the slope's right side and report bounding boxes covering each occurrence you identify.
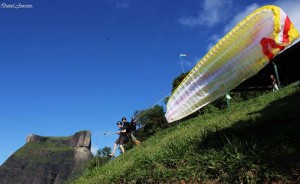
[197,89,300,183]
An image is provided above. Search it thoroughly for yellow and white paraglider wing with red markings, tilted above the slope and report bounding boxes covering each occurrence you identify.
[165,5,299,123]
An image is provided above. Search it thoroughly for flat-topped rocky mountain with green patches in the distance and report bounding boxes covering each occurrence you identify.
[0,131,91,184]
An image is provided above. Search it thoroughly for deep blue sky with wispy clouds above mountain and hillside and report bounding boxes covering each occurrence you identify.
[0,0,300,164]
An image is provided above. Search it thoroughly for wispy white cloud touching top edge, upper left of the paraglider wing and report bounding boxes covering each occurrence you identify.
[179,0,231,27]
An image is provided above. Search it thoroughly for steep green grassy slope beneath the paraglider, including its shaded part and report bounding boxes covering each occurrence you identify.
[76,83,300,183]
